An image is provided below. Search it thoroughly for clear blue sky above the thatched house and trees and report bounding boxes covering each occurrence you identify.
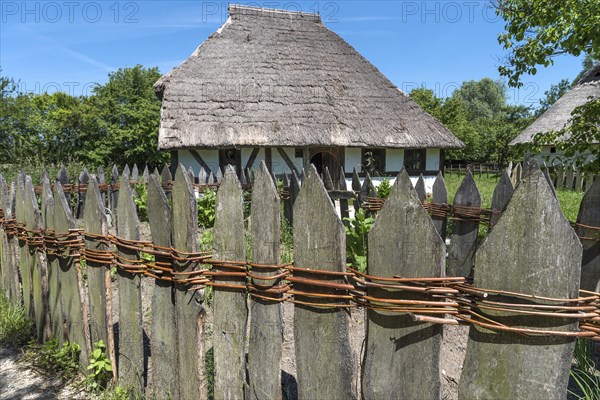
[0,0,581,106]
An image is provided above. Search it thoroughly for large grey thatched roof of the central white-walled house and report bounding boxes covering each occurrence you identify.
[155,5,463,149]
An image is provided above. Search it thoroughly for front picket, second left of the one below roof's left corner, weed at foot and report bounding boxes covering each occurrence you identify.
[83,179,114,354]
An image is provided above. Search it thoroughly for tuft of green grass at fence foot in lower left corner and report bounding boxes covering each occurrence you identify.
[0,291,33,347]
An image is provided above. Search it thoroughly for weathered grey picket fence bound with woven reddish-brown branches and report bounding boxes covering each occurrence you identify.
[0,164,600,399]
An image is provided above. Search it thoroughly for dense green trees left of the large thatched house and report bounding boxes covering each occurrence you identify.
[0,65,169,170]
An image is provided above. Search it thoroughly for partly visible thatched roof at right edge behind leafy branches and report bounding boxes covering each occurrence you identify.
[510,64,600,145]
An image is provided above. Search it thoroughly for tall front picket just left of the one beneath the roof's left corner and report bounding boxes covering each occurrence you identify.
[117,170,144,391]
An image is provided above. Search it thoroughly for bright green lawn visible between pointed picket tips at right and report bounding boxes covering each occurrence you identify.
[444,173,583,221]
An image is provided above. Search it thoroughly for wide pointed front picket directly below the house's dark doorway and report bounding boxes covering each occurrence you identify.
[294,165,356,399]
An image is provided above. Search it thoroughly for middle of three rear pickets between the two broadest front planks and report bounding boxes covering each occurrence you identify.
[446,172,480,276]
